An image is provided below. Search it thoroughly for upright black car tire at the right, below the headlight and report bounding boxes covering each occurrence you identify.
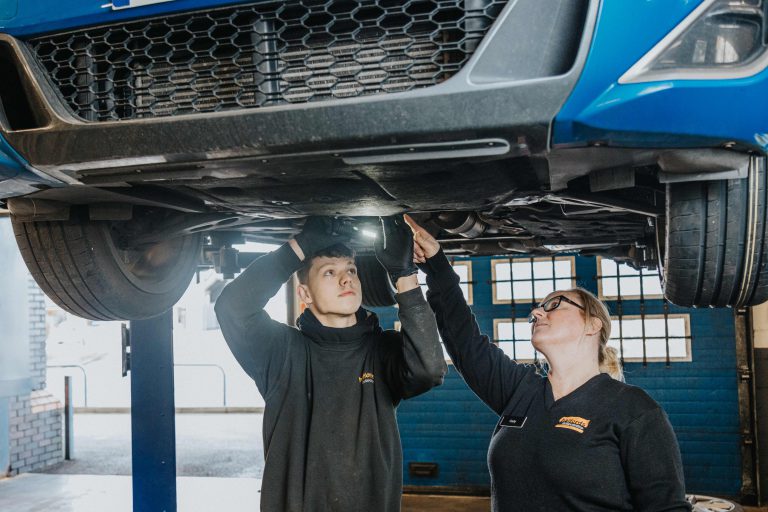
[660,158,768,307]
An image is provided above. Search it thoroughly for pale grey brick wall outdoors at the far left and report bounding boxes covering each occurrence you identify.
[9,278,64,476]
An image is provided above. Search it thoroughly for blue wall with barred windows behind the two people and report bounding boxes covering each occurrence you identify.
[377,257,741,496]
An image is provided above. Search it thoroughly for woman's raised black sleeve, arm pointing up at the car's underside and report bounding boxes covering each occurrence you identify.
[419,250,530,414]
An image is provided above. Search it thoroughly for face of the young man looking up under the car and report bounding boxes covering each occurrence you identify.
[299,256,363,325]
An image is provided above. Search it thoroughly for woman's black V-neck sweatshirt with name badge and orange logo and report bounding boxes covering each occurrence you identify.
[420,251,690,512]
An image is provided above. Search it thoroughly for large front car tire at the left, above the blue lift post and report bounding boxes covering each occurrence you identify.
[11,210,201,320]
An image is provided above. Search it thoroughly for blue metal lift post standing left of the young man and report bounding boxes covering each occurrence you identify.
[130,310,176,512]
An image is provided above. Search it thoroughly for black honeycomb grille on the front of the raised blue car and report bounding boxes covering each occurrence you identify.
[28,0,507,121]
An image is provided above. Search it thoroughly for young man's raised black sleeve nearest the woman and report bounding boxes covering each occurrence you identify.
[391,288,448,398]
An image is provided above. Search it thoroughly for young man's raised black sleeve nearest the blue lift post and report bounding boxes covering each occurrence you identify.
[215,244,301,400]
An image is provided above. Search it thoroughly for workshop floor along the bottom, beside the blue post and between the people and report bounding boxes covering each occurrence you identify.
[0,473,490,512]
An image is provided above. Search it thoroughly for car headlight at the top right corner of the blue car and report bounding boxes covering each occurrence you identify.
[619,0,768,84]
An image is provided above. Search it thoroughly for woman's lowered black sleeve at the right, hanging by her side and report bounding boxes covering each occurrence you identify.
[621,407,691,512]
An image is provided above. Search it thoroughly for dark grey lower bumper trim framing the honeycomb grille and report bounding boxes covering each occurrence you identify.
[0,0,597,172]
